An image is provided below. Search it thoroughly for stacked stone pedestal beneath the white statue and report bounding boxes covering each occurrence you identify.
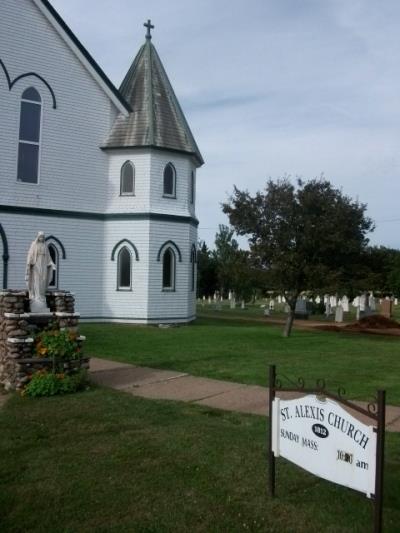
[0,290,89,390]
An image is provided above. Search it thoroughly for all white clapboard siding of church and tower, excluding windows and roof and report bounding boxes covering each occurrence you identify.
[0,0,197,323]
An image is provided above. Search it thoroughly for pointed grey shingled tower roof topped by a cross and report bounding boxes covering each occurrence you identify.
[104,28,204,165]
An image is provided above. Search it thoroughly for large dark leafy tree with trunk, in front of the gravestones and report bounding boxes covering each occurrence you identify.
[222,178,374,337]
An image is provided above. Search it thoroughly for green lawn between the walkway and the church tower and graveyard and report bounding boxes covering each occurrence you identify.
[81,317,400,404]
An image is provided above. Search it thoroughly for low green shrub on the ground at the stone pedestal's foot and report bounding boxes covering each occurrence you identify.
[23,370,87,398]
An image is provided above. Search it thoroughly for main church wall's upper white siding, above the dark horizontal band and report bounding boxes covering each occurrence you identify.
[0,0,117,211]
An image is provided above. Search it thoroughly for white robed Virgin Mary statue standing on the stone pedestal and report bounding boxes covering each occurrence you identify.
[25,231,56,313]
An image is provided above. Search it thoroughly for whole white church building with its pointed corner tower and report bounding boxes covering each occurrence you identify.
[0,0,203,324]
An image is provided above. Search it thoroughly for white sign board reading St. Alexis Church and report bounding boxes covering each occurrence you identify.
[272,395,376,497]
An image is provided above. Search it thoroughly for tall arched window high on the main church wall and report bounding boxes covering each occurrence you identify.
[17,87,42,183]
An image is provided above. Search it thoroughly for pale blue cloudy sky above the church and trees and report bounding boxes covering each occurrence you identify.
[52,0,400,248]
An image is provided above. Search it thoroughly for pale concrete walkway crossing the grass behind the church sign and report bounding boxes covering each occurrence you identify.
[90,357,400,432]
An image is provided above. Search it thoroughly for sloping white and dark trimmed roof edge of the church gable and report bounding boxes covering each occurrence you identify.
[32,0,131,115]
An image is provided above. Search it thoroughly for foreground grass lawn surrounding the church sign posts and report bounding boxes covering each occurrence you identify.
[0,389,400,533]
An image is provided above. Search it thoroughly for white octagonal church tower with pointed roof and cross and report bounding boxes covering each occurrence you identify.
[102,21,204,323]
